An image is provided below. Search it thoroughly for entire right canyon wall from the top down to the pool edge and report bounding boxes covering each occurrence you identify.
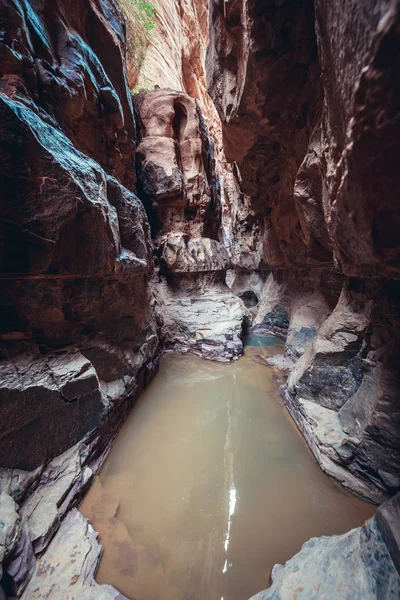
[207,0,400,501]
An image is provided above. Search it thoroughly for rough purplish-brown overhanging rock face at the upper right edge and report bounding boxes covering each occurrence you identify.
[310,0,400,277]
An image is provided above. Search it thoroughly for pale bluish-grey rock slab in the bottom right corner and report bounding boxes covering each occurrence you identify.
[252,518,400,600]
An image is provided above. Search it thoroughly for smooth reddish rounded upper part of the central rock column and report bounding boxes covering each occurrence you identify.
[135,89,221,238]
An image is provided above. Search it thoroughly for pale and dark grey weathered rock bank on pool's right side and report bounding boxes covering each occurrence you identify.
[283,281,400,502]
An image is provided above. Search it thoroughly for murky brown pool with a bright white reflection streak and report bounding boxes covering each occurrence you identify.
[81,340,374,600]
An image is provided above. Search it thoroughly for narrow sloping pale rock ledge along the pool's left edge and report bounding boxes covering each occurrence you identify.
[0,339,158,597]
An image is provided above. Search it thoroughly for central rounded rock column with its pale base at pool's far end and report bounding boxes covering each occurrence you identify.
[135,89,247,361]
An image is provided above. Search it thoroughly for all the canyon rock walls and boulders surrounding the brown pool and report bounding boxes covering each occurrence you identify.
[0,0,400,599]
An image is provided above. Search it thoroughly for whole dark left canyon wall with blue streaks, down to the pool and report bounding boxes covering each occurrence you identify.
[0,0,159,598]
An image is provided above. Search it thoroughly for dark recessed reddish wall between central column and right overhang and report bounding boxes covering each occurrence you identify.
[207,0,322,268]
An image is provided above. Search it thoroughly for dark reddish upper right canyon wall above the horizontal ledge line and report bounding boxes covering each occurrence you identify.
[207,0,399,276]
